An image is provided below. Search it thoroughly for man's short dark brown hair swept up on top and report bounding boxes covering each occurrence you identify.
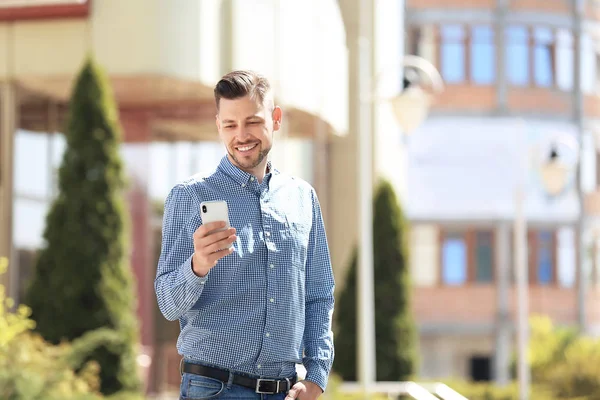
[214,70,271,110]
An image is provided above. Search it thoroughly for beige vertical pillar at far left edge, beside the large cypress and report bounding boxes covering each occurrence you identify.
[0,81,18,300]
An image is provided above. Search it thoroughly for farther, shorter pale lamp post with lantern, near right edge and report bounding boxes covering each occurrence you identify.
[514,135,579,400]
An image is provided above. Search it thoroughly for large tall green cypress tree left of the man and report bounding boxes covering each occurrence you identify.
[25,59,140,394]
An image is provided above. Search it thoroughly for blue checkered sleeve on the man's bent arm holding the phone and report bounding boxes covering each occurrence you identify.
[154,185,208,321]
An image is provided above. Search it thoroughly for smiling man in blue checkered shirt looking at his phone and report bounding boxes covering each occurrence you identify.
[155,71,334,400]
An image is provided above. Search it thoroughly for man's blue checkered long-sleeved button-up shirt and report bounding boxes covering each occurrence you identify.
[154,156,334,390]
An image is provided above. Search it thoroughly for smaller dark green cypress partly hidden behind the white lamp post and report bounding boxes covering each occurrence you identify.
[333,181,418,381]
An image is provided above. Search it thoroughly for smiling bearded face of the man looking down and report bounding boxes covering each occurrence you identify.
[217,96,281,173]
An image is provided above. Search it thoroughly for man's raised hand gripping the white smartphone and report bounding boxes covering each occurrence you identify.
[192,222,237,276]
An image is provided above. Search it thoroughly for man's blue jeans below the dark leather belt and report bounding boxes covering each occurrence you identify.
[179,373,286,400]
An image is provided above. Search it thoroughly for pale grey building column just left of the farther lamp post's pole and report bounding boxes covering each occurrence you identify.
[494,222,512,386]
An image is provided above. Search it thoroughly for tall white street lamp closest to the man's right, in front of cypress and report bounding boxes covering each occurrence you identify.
[357,50,444,394]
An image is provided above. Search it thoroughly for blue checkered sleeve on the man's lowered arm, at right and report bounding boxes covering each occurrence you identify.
[303,191,335,391]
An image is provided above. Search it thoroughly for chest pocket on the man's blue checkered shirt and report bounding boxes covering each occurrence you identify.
[280,216,311,270]
